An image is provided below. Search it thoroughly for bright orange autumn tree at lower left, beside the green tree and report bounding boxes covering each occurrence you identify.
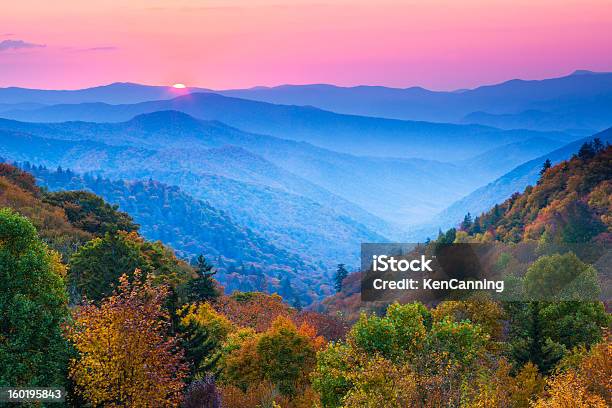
[69,272,187,407]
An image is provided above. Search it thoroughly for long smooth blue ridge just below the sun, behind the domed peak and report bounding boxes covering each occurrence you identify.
[0,93,576,161]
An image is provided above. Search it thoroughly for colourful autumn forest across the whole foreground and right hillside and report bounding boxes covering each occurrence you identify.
[0,143,612,408]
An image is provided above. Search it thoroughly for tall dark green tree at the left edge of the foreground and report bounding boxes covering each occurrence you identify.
[0,209,69,387]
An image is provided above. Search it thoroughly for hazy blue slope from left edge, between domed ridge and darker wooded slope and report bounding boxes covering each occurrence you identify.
[0,125,385,266]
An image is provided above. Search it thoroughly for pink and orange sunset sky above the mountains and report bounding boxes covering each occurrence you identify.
[0,0,612,89]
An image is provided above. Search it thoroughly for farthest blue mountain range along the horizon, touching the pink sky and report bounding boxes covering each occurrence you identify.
[0,70,612,132]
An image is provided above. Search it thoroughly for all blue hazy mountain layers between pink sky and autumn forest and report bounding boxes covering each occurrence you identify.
[0,72,612,300]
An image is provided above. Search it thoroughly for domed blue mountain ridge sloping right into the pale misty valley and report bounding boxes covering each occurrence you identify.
[0,111,491,226]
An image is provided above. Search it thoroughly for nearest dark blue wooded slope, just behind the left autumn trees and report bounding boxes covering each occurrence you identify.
[2,163,331,304]
